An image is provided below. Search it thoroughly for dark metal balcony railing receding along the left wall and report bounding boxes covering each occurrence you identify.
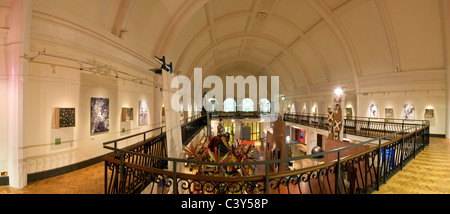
[103,115,206,194]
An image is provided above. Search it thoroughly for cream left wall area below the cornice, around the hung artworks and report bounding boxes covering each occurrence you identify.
[25,60,153,173]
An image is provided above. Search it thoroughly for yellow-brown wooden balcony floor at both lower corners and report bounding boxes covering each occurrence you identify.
[0,138,450,194]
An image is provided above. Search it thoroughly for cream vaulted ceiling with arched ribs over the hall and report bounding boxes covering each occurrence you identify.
[35,0,447,95]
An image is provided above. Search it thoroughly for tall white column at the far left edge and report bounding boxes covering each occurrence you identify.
[6,0,33,188]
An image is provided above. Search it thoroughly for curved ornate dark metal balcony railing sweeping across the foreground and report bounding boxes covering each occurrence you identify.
[104,115,429,194]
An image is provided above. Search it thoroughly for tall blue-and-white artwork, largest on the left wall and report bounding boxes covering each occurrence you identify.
[91,97,109,134]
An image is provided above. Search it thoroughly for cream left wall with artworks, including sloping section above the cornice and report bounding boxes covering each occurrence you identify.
[20,5,160,176]
